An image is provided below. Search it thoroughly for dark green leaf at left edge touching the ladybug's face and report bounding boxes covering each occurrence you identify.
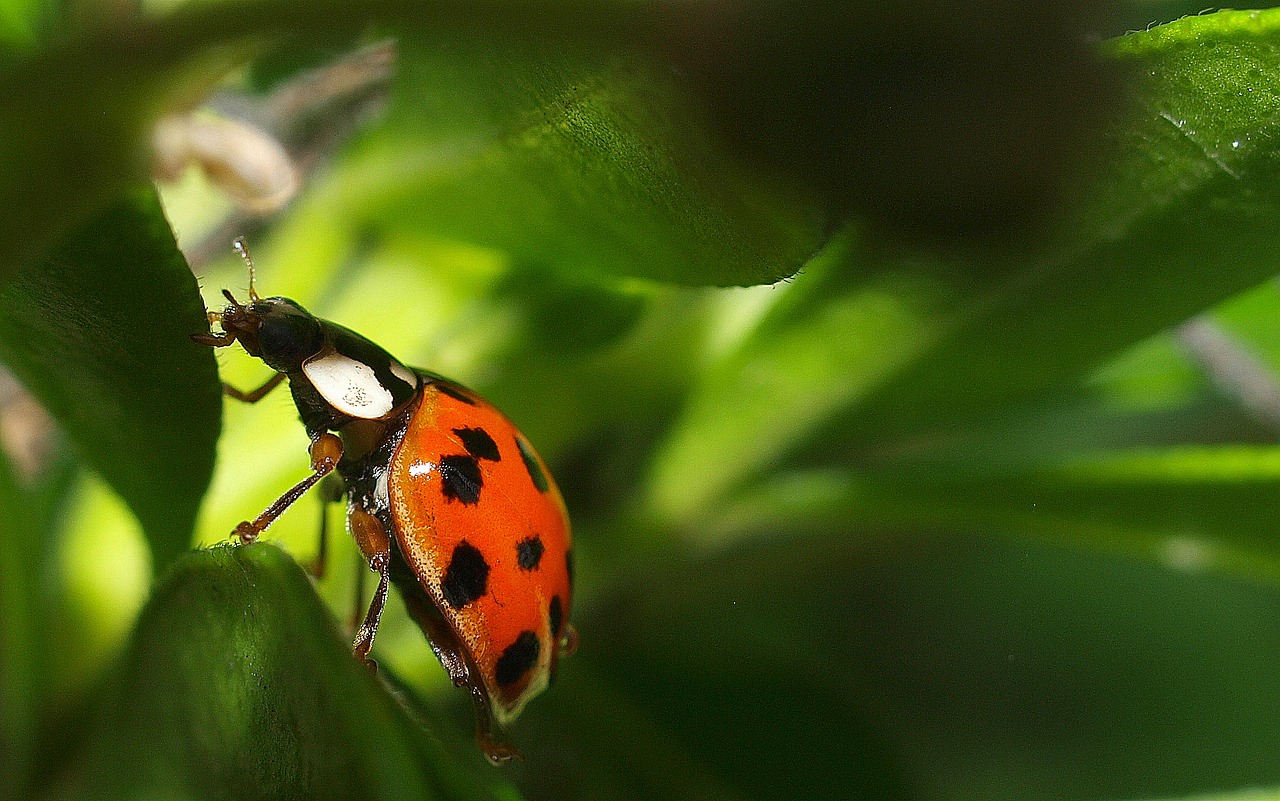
[0,188,221,568]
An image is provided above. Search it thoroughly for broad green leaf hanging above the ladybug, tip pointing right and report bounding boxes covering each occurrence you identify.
[344,37,824,284]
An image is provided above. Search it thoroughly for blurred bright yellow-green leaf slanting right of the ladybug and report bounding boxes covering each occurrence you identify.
[649,252,940,528]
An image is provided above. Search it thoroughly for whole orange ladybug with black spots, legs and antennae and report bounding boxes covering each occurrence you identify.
[192,239,577,763]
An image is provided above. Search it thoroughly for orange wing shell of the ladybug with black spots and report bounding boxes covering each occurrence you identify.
[388,376,573,724]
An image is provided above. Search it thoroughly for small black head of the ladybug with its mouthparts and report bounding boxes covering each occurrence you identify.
[195,290,324,372]
